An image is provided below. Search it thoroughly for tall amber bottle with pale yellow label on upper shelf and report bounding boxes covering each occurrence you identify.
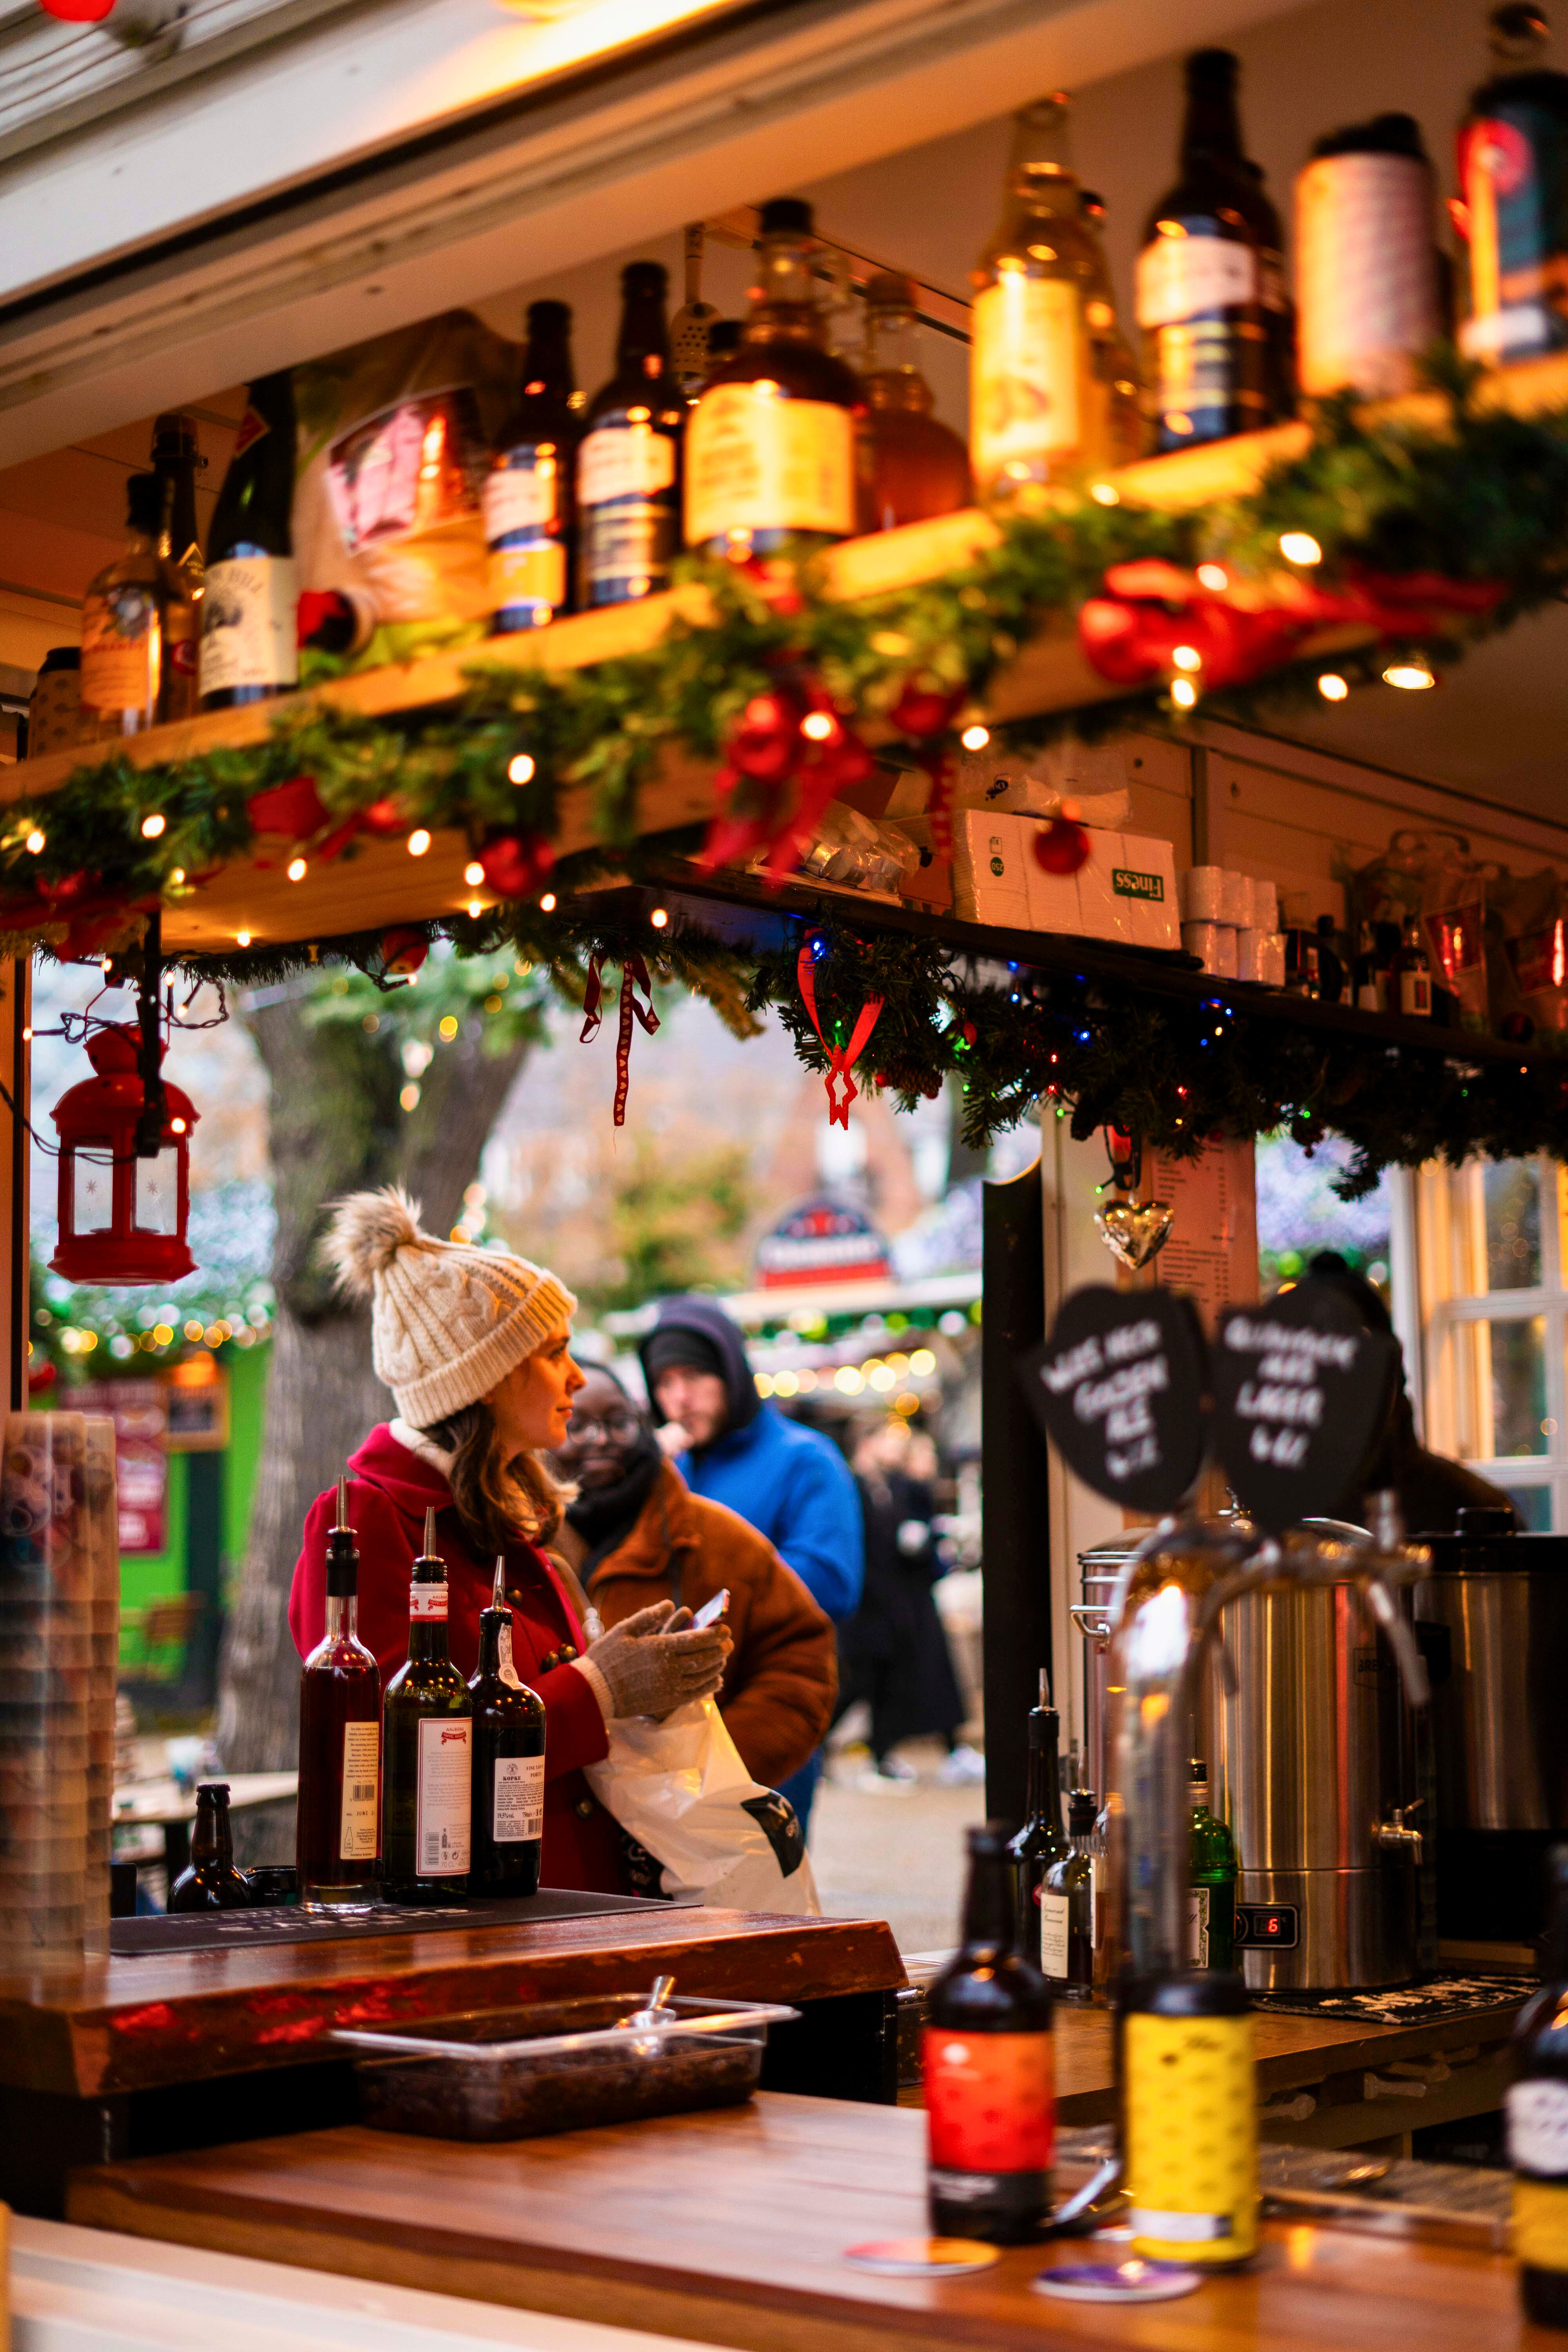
[969,92,1112,501]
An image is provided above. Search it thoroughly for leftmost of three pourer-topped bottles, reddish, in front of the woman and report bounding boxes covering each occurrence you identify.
[294,1479,381,1910]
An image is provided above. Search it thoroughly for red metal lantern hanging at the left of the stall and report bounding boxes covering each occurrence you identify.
[49,1023,198,1284]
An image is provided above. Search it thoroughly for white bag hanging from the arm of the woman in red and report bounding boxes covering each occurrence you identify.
[588,1698,823,1917]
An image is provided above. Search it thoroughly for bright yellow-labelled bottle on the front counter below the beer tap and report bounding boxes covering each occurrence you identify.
[1121,1971,1258,2267]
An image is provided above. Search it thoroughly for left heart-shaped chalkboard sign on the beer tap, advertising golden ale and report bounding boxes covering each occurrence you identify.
[1018,1282,1208,1510]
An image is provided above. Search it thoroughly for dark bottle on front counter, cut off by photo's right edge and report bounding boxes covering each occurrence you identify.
[1505,1846,1568,2328]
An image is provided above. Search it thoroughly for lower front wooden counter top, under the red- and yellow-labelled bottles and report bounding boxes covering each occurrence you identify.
[68,2093,1532,2352]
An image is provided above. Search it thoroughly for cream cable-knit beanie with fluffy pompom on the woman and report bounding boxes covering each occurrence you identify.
[322,1183,576,1430]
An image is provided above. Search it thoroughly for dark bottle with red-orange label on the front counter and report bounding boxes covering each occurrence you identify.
[922,1820,1056,2246]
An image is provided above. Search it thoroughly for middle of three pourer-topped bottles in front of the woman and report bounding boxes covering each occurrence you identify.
[381,1510,472,1903]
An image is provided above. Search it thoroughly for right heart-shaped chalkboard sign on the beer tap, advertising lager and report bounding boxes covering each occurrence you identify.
[1213,1282,1399,1536]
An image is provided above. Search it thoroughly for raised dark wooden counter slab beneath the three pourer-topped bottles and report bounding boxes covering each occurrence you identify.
[0,1905,905,2098]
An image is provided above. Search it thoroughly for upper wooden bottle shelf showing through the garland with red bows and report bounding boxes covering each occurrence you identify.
[12,339,1568,953]
